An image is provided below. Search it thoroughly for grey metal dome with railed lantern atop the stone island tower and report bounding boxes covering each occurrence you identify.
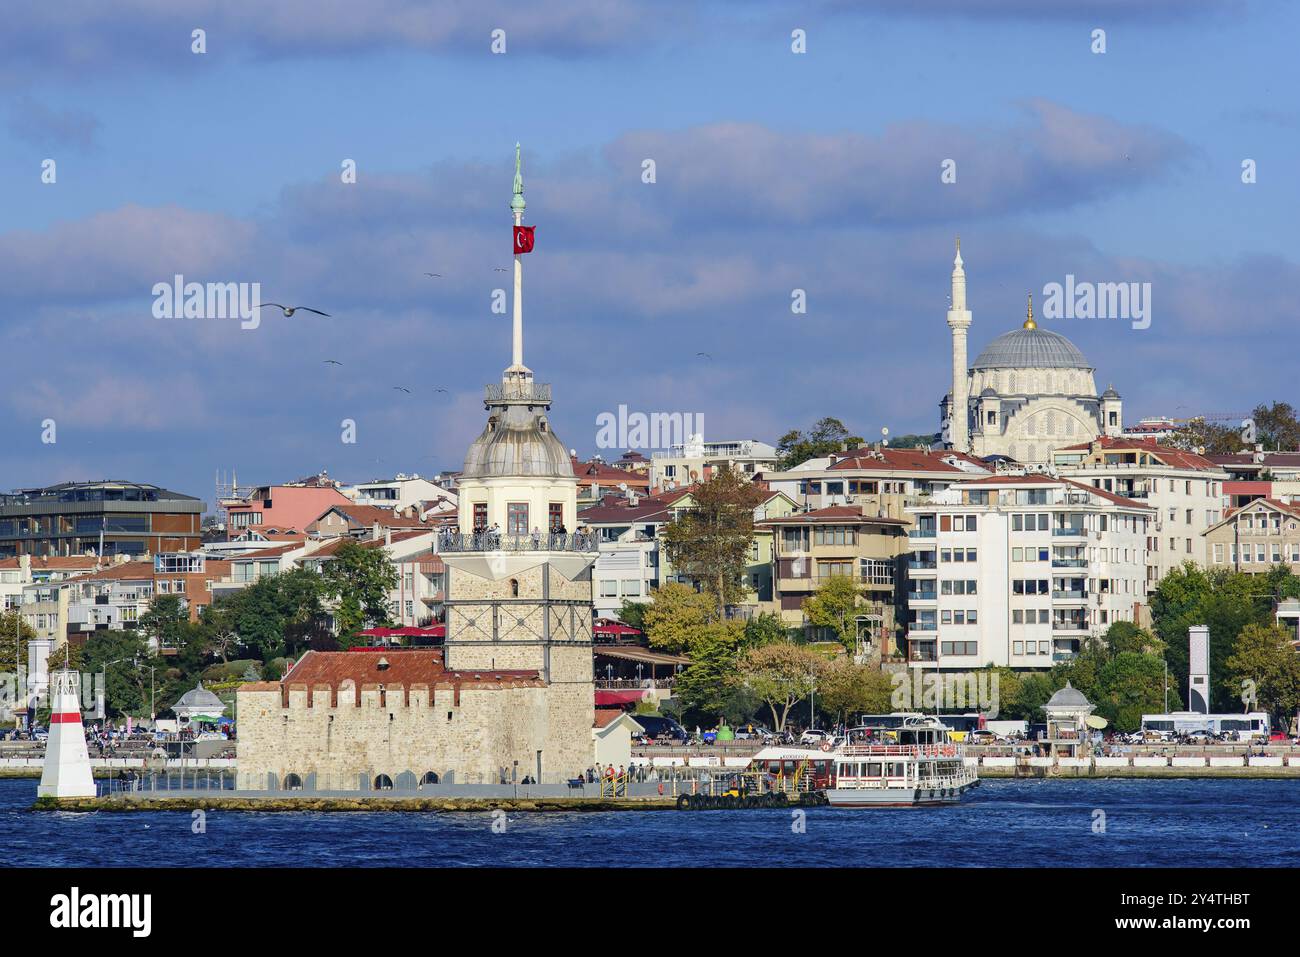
[462,384,573,479]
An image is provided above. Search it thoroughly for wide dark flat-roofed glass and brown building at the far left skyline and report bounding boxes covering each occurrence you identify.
[0,481,204,558]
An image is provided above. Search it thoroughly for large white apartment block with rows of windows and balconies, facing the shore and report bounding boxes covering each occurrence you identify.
[907,475,1154,671]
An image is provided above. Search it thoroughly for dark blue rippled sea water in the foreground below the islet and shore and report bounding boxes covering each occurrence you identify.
[10,779,1300,867]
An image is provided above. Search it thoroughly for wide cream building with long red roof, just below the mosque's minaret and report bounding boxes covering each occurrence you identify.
[763,446,992,519]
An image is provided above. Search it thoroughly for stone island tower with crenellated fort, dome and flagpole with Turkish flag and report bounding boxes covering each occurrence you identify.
[238,146,597,791]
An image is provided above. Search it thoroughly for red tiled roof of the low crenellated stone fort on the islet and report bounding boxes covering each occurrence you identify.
[276,648,545,703]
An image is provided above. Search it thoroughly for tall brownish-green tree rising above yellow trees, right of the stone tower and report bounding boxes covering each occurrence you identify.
[663,468,767,618]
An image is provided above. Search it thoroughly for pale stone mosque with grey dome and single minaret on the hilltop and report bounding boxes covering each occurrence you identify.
[940,241,1123,464]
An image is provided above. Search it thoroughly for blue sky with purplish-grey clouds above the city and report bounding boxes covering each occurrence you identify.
[0,0,1300,503]
